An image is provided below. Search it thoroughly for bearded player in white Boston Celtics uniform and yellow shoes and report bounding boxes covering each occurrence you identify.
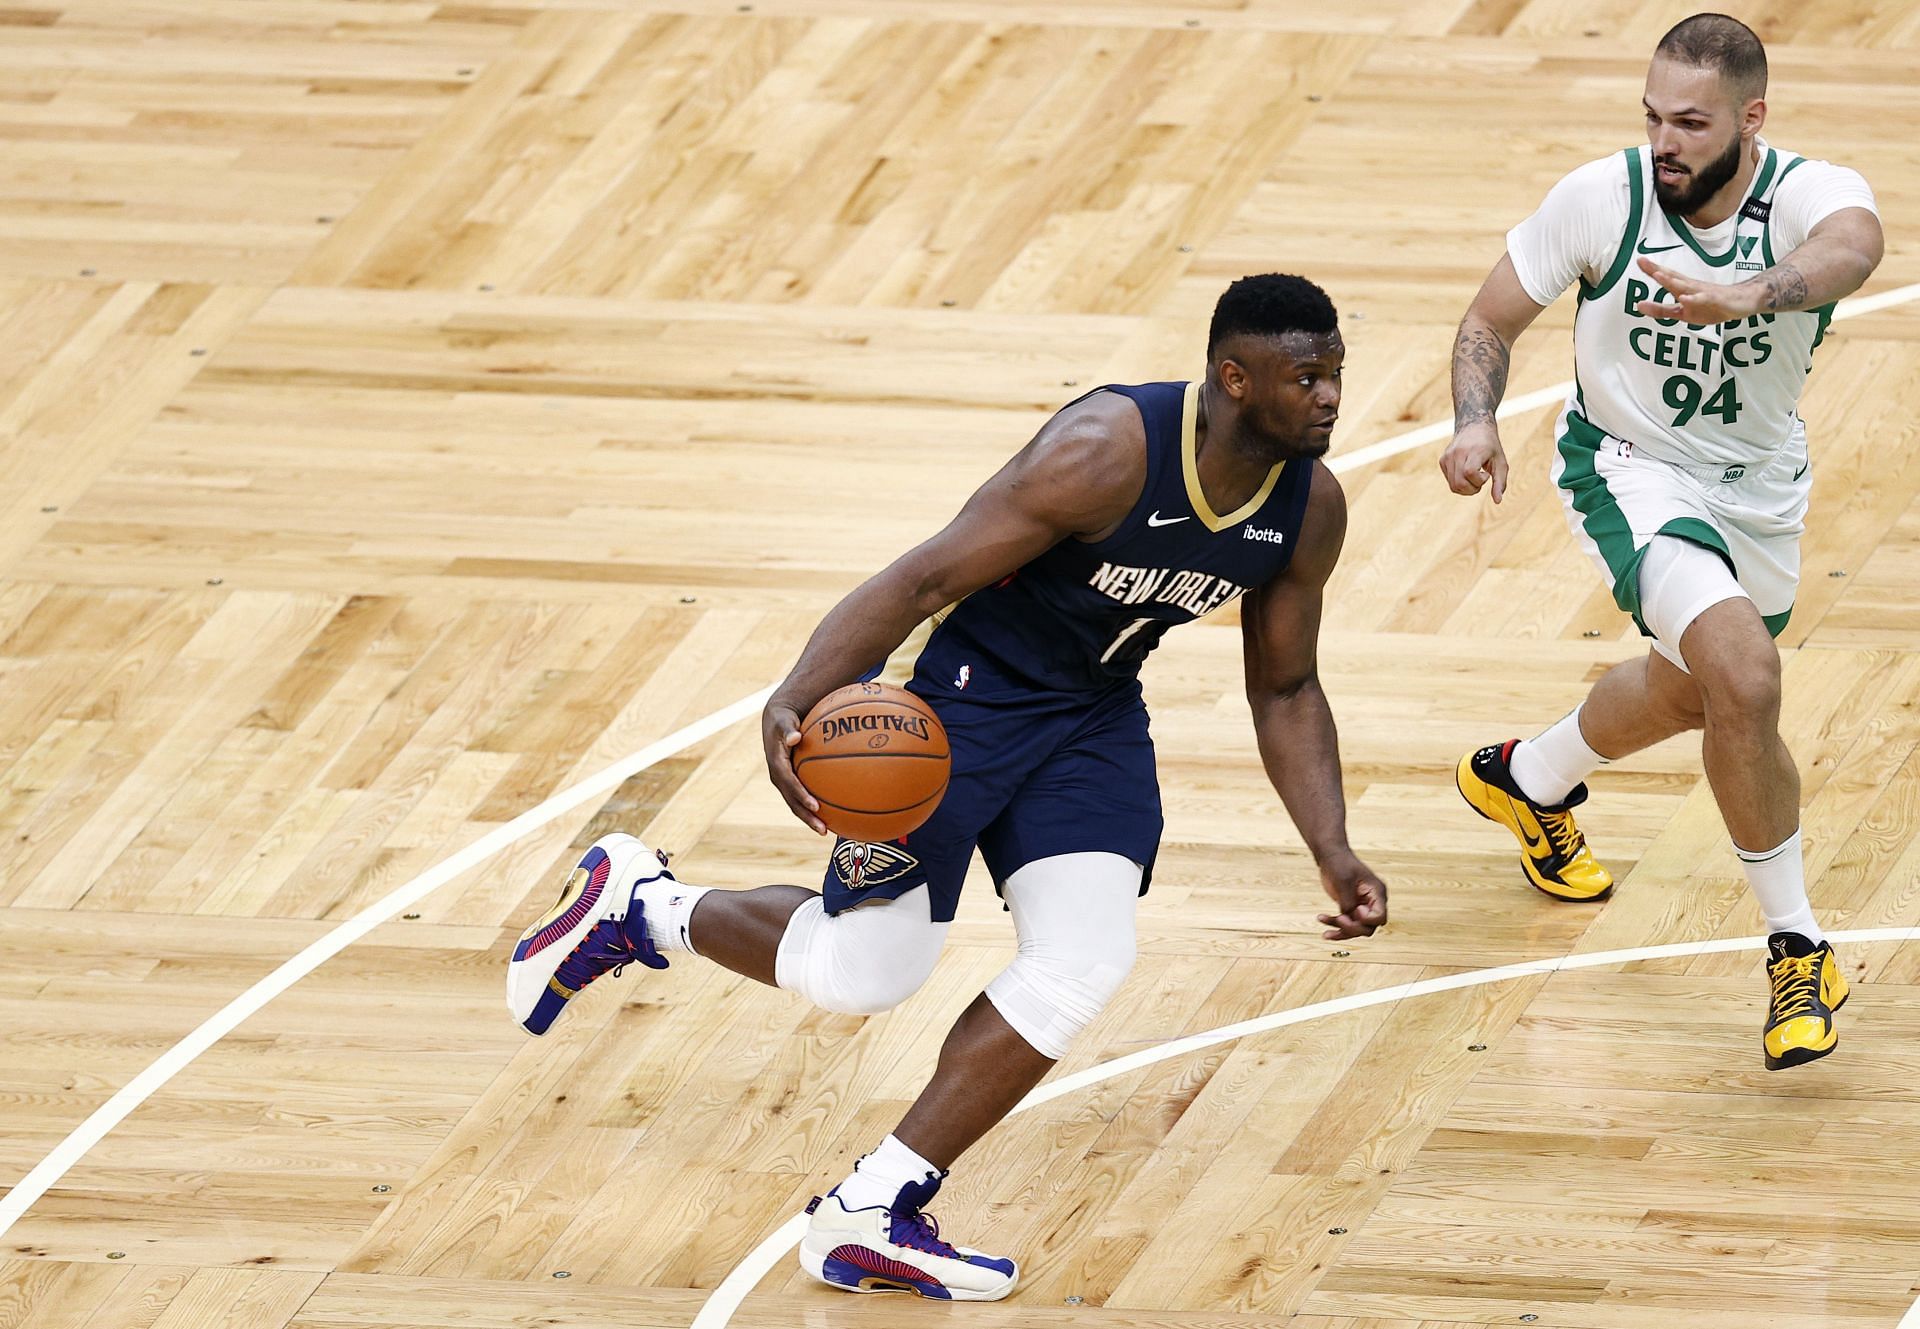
[1440,13,1882,1070]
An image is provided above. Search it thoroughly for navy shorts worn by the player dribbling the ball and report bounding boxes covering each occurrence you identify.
[822,638,1162,922]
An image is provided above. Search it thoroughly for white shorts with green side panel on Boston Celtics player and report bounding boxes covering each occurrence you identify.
[1553,409,1812,668]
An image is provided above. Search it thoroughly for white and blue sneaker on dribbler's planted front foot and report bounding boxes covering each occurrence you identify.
[801,1187,1020,1302]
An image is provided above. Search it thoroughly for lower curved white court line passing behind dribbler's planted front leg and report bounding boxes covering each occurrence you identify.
[691,928,1920,1329]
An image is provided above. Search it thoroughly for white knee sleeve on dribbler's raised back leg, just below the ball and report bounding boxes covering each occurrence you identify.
[774,885,947,1016]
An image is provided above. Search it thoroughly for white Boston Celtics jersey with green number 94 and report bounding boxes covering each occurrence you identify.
[1571,148,1834,467]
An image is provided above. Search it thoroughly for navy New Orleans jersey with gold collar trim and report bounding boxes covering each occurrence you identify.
[929,382,1313,691]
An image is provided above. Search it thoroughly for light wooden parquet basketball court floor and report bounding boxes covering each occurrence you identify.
[0,0,1920,1329]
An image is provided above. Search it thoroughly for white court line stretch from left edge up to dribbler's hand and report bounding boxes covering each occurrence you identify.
[0,688,774,1235]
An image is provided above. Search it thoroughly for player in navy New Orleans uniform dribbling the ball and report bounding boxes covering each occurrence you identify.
[507,275,1386,1300]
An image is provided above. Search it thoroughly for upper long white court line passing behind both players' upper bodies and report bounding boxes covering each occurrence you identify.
[0,272,1920,1305]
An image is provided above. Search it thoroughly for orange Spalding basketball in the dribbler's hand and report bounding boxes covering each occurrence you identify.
[793,684,952,841]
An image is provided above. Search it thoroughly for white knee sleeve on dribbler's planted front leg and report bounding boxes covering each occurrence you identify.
[987,853,1140,1060]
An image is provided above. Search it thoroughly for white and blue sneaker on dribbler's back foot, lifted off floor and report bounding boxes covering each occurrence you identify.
[507,834,674,1033]
